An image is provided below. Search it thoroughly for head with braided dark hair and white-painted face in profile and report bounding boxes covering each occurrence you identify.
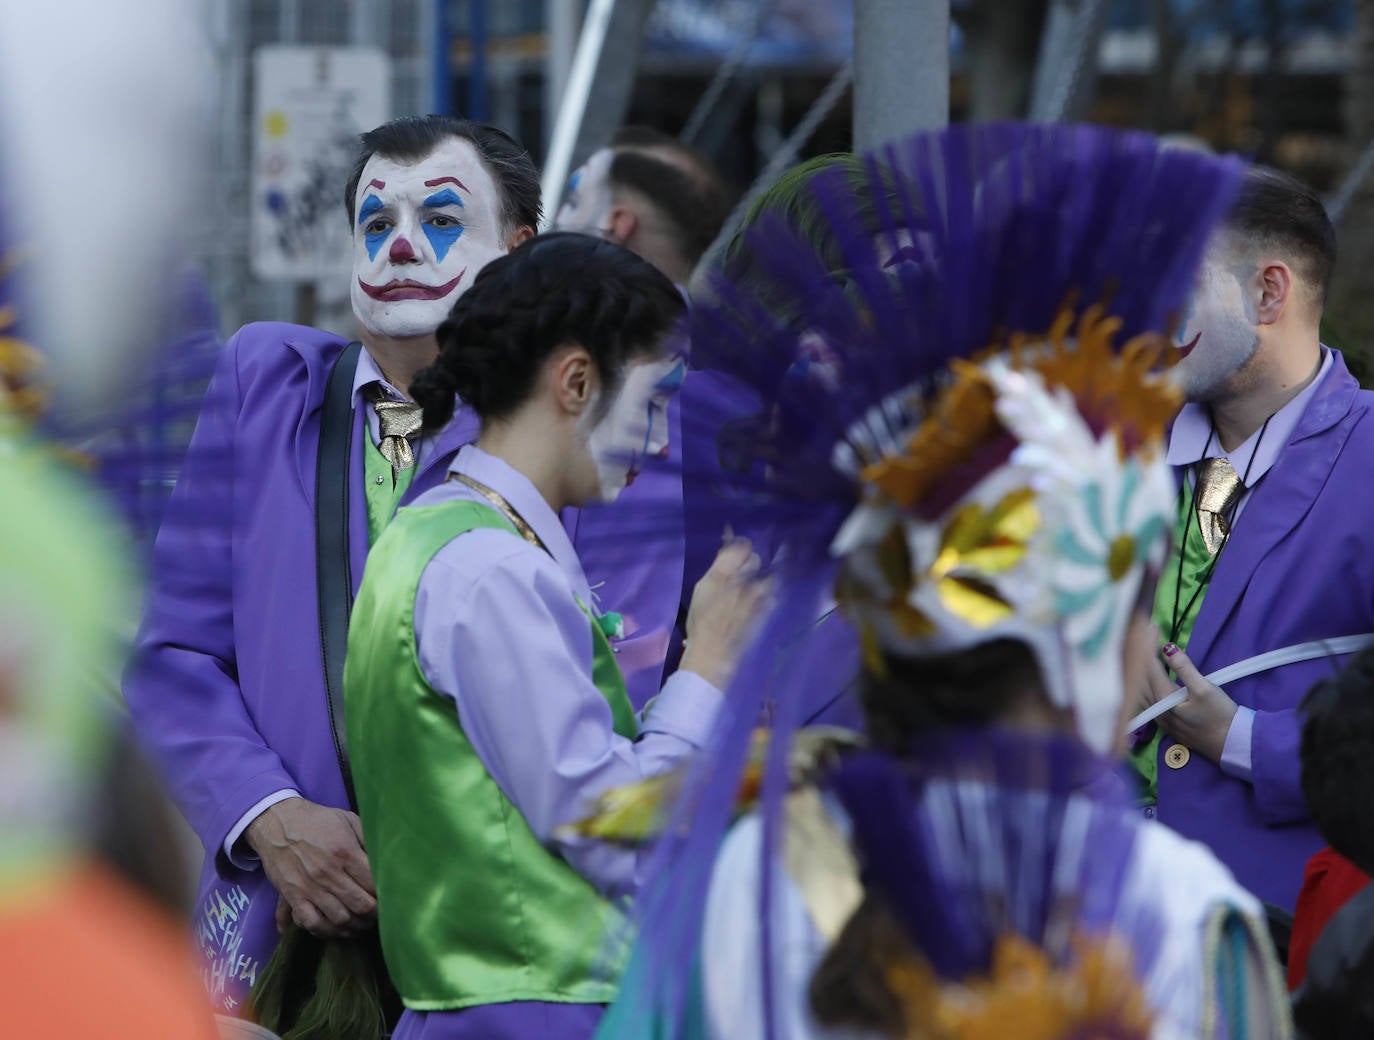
[411,232,686,508]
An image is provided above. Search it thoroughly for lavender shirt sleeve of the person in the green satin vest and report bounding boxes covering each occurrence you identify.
[415,529,723,896]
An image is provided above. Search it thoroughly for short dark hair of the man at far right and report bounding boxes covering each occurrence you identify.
[1224,166,1336,308]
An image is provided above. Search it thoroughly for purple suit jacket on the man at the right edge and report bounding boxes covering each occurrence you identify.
[1158,353,1374,911]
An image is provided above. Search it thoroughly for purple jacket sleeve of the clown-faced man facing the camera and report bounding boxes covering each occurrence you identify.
[124,332,297,849]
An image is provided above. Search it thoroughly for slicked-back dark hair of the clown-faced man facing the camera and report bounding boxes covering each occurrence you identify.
[344,115,541,236]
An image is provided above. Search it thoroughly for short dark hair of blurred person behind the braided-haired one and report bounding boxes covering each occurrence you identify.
[607,126,732,267]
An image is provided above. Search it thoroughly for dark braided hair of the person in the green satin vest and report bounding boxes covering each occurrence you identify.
[411,231,686,430]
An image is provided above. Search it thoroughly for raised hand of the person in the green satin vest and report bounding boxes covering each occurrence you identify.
[680,534,772,690]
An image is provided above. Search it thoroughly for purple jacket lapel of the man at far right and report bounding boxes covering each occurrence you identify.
[1189,353,1359,669]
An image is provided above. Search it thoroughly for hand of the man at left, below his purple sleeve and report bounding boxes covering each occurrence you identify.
[243,798,376,936]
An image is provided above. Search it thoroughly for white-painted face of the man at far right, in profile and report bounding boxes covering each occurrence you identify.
[1173,243,1259,401]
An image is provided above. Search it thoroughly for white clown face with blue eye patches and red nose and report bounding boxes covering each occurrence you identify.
[350,137,506,339]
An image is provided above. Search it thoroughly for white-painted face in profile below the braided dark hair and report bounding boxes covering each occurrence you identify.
[587,357,687,501]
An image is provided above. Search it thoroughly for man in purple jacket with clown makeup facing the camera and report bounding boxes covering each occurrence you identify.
[125,115,540,1013]
